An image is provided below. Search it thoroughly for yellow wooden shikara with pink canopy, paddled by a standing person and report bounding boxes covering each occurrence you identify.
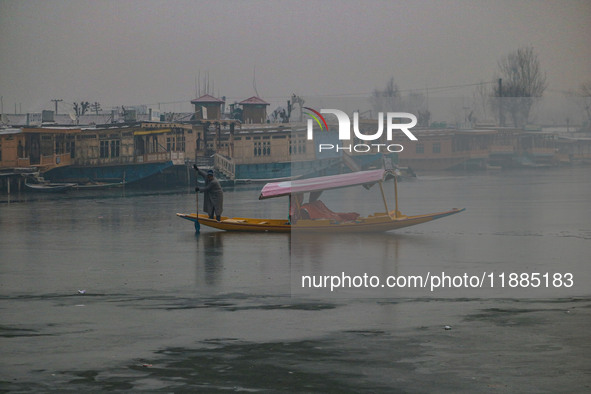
[177,169,464,233]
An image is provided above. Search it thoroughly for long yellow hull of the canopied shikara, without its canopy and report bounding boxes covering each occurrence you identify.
[177,208,464,233]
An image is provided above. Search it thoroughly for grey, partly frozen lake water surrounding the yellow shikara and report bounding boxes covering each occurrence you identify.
[0,168,591,393]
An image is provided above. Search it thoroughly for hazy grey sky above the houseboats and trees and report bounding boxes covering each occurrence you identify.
[0,0,591,113]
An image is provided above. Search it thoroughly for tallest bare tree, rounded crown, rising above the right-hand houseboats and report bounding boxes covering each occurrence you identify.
[493,46,547,127]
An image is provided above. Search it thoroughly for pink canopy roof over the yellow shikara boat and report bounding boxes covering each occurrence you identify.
[259,169,394,200]
